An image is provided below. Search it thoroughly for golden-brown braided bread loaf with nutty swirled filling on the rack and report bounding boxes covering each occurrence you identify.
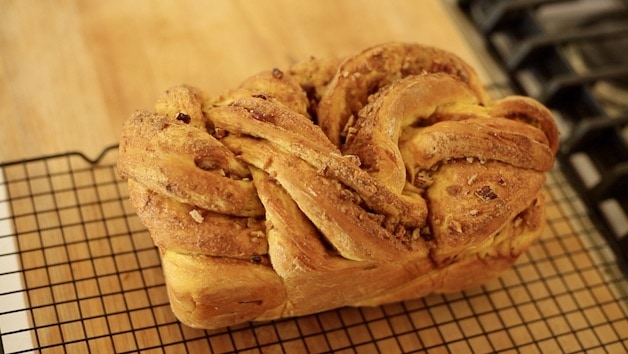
[118,43,558,328]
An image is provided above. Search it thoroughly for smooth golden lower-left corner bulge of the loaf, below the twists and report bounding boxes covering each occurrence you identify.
[161,249,286,328]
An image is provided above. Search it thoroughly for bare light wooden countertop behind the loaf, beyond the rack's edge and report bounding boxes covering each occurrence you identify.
[0,0,486,162]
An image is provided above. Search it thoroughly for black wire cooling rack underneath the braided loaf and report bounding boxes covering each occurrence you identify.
[0,142,628,353]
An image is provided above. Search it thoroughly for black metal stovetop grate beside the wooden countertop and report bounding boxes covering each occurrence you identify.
[457,0,628,261]
